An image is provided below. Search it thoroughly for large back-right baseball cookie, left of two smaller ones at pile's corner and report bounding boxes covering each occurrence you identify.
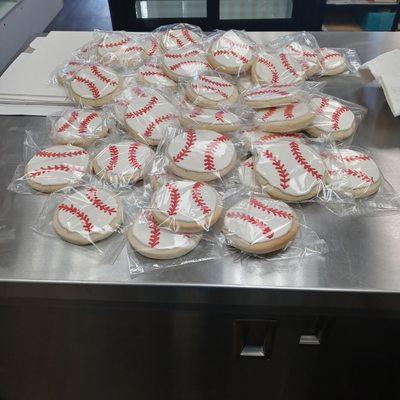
[251,53,305,85]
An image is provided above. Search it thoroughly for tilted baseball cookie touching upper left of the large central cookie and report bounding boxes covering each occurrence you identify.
[125,95,177,146]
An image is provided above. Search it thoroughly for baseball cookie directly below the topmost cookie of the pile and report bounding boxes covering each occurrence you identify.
[161,49,212,82]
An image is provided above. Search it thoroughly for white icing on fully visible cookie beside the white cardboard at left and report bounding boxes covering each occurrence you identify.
[71,65,119,100]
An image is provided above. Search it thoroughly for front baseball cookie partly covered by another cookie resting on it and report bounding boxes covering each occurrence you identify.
[128,210,201,260]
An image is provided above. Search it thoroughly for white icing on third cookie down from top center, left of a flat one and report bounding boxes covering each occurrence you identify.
[188,75,235,101]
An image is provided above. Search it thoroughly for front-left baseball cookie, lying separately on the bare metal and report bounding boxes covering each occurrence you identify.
[53,187,122,245]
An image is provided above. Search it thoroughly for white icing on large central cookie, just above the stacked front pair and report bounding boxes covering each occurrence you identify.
[167,129,235,173]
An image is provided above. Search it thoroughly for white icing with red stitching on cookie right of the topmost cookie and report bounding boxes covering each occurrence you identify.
[210,31,253,69]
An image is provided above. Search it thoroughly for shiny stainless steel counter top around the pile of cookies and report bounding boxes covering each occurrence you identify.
[0,32,400,310]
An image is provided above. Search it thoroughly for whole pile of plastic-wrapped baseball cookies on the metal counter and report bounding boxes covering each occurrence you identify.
[12,24,381,259]
